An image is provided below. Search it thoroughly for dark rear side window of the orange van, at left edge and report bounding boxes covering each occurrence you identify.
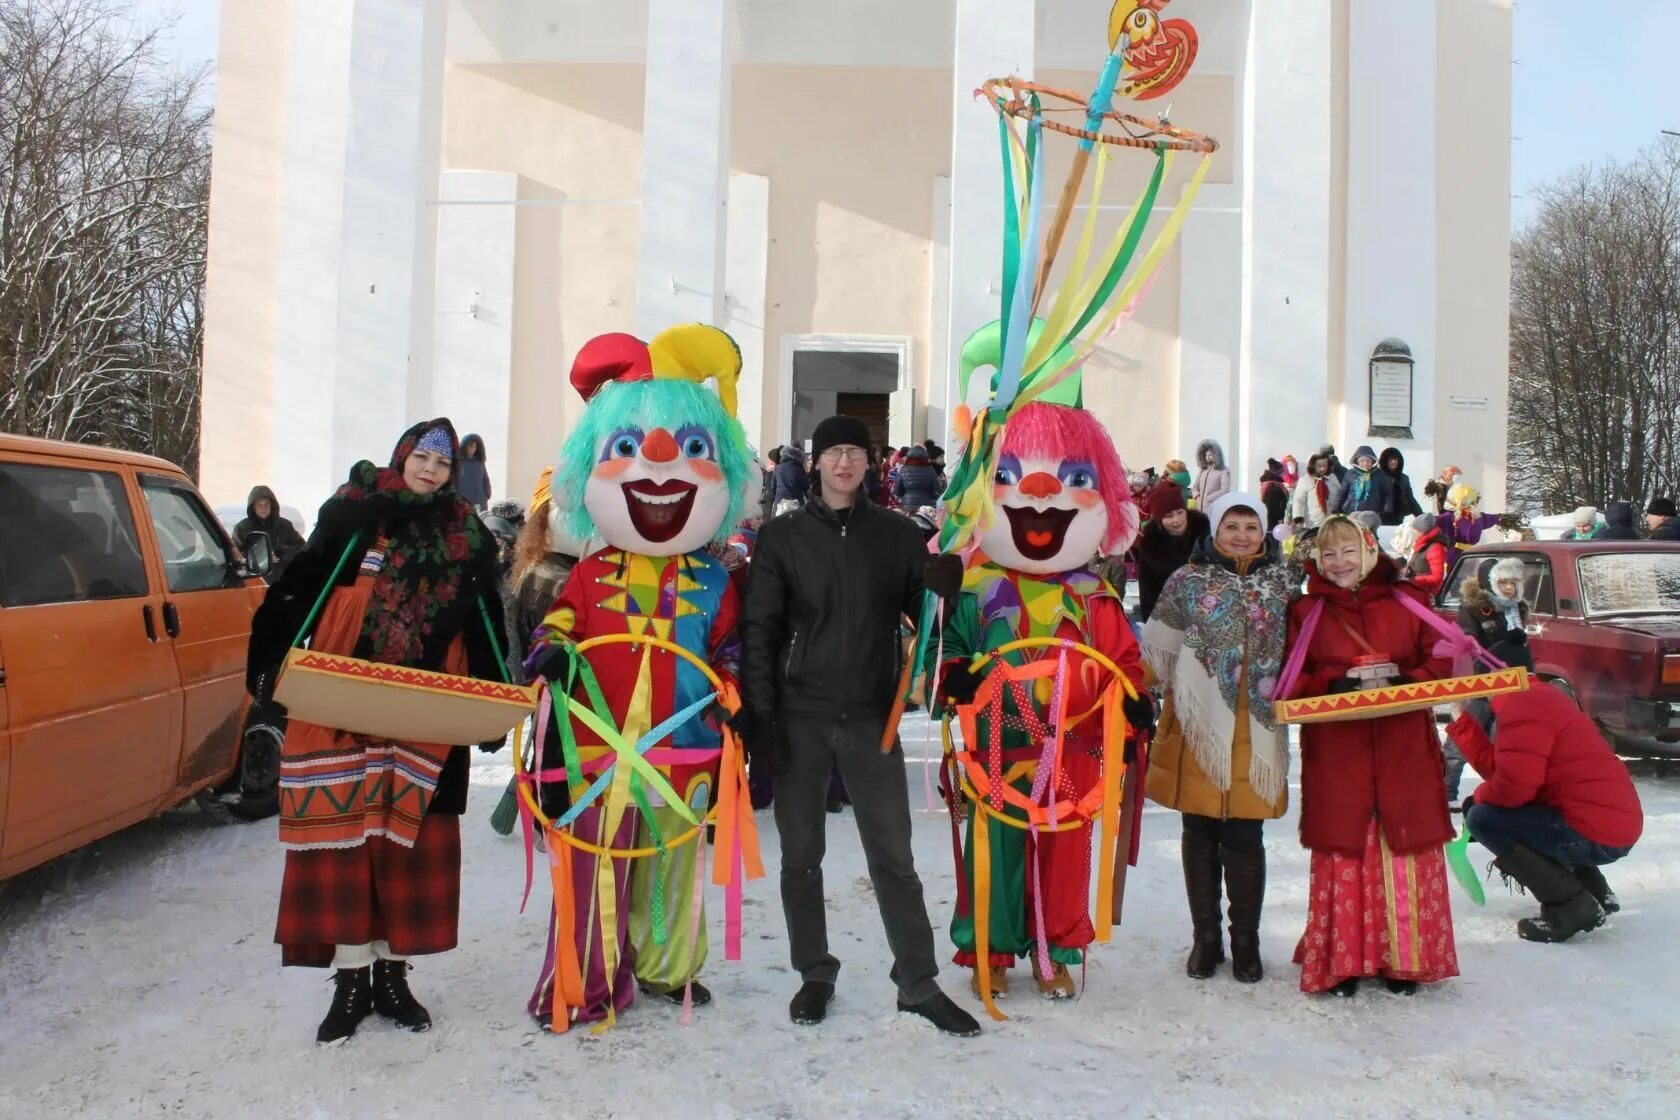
[0,463,146,606]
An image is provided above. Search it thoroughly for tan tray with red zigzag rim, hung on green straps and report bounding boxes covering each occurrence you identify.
[274,650,536,746]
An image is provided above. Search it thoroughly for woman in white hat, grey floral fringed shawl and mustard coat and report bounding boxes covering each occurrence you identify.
[1144,494,1300,984]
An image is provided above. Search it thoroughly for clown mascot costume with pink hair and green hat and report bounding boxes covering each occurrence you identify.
[927,324,1152,999]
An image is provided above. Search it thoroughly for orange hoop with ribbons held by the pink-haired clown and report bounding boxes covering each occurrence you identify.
[941,638,1137,1023]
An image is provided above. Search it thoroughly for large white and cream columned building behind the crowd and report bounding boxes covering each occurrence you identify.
[202,0,1512,509]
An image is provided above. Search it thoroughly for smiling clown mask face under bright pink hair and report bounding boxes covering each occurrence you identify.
[979,455,1109,576]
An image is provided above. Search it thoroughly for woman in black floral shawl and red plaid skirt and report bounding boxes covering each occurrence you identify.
[245,420,506,1043]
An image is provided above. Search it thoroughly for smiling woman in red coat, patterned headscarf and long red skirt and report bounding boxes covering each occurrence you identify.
[1289,517,1458,996]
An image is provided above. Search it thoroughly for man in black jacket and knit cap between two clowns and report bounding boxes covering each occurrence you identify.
[741,416,979,1036]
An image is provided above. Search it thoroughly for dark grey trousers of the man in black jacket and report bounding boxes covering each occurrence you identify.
[774,715,939,1002]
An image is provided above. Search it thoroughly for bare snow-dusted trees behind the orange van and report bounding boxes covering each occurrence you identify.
[0,0,210,472]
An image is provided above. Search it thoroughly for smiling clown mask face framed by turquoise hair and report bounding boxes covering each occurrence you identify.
[583,425,729,556]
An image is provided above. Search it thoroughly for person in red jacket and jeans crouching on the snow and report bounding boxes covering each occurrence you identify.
[1448,633,1645,942]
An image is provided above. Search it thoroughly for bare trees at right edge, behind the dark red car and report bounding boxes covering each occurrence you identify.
[1510,139,1680,509]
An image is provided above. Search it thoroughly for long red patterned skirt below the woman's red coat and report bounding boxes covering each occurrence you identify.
[1295,819,1458,992]
